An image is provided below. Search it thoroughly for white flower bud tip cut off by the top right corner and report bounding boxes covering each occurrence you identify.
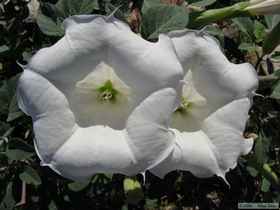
[245,0,280,15]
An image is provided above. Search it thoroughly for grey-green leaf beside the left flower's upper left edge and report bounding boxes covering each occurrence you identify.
[37,12,64,36]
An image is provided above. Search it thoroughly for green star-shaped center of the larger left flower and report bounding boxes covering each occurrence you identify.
[97,80,119,102]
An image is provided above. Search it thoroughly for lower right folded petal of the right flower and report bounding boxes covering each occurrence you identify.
[202,98,253,171]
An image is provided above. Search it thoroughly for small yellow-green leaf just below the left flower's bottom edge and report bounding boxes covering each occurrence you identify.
[123,178,144,205]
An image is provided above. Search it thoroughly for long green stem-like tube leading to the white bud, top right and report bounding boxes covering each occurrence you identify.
[188,2,250,28]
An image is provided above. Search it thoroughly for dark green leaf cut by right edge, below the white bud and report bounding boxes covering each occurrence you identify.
[263,22,280,54]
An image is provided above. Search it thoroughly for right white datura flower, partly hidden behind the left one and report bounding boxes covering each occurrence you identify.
[151,30,258,183]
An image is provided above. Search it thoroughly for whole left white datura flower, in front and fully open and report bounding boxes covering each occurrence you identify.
[17,15,183,180]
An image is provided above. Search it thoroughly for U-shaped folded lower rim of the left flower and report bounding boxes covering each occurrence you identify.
[17,70,177,180]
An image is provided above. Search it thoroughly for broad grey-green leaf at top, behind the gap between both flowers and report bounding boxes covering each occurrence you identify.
[141,4,189,39]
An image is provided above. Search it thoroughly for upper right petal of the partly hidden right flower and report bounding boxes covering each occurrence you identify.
[166,30,258,110]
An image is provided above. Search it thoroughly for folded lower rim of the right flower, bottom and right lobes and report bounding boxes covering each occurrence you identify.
[151,98,253,182]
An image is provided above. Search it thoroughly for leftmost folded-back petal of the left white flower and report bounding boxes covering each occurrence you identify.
[17,70,77,163]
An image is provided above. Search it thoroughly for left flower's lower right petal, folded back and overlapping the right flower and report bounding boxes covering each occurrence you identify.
[127,88,178,171]
